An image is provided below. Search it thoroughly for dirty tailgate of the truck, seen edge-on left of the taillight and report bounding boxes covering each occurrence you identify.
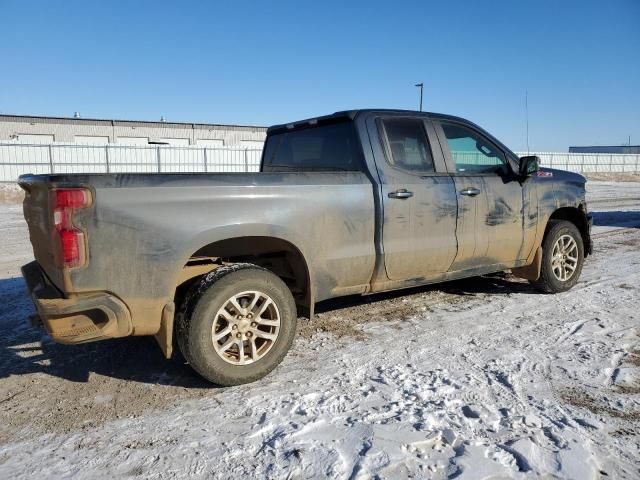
[18,175,63,290]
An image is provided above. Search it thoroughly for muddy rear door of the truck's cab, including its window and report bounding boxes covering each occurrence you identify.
[367,114,457,281]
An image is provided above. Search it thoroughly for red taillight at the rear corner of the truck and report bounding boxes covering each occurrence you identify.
[51,188,91,268]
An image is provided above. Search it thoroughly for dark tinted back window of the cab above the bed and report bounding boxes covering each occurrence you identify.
[262,122,362,172]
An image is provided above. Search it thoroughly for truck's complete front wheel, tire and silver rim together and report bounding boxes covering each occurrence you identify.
[531,220,584,293]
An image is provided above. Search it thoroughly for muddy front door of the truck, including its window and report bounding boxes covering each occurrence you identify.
[434,120,529,271]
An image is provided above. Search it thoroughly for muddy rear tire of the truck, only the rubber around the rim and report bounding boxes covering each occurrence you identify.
[176,263,297,386]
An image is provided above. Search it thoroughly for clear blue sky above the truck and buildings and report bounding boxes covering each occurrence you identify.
[0,0,640,151]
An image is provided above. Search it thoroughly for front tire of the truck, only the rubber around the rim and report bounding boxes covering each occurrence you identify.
[531,220,584,293]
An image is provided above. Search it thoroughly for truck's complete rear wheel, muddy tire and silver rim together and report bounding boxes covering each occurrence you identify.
[176,264,297,386]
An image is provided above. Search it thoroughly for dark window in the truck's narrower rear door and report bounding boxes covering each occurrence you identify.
[382,118,434,172]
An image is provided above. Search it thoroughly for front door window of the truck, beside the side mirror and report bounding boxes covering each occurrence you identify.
[442,123,507,173]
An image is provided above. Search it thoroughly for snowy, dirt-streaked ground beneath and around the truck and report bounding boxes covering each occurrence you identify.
[0,182,640,479]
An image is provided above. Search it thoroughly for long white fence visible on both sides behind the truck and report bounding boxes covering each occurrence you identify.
[0,143,640,182]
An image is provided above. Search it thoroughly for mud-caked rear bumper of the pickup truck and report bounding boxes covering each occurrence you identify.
[22,262,132,343]
